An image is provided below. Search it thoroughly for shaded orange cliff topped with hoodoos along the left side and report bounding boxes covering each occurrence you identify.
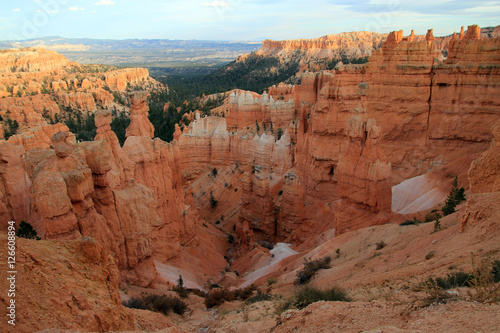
[0,94,219,286]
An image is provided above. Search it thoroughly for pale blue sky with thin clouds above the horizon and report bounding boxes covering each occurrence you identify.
[0,0,500,41]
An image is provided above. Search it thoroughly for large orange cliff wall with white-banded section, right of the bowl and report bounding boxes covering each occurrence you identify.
[178,26,500,242]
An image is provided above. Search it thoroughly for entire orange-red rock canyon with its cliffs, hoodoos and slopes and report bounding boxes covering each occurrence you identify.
[0,26,500,332]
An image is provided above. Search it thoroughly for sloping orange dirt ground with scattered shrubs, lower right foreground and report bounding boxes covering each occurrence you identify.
[113,201,500,332]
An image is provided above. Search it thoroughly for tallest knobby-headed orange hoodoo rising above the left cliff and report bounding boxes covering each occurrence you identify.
[125,91,155,138]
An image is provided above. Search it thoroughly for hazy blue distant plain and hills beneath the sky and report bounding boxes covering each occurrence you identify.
[0,36,261,68]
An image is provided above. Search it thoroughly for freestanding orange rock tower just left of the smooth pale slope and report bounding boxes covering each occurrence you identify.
[335,116,392,234]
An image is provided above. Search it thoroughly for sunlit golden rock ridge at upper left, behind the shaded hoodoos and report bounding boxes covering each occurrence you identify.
[0,49,162,129]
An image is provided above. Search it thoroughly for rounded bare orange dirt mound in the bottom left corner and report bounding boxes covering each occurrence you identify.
[0,233,180,332]
